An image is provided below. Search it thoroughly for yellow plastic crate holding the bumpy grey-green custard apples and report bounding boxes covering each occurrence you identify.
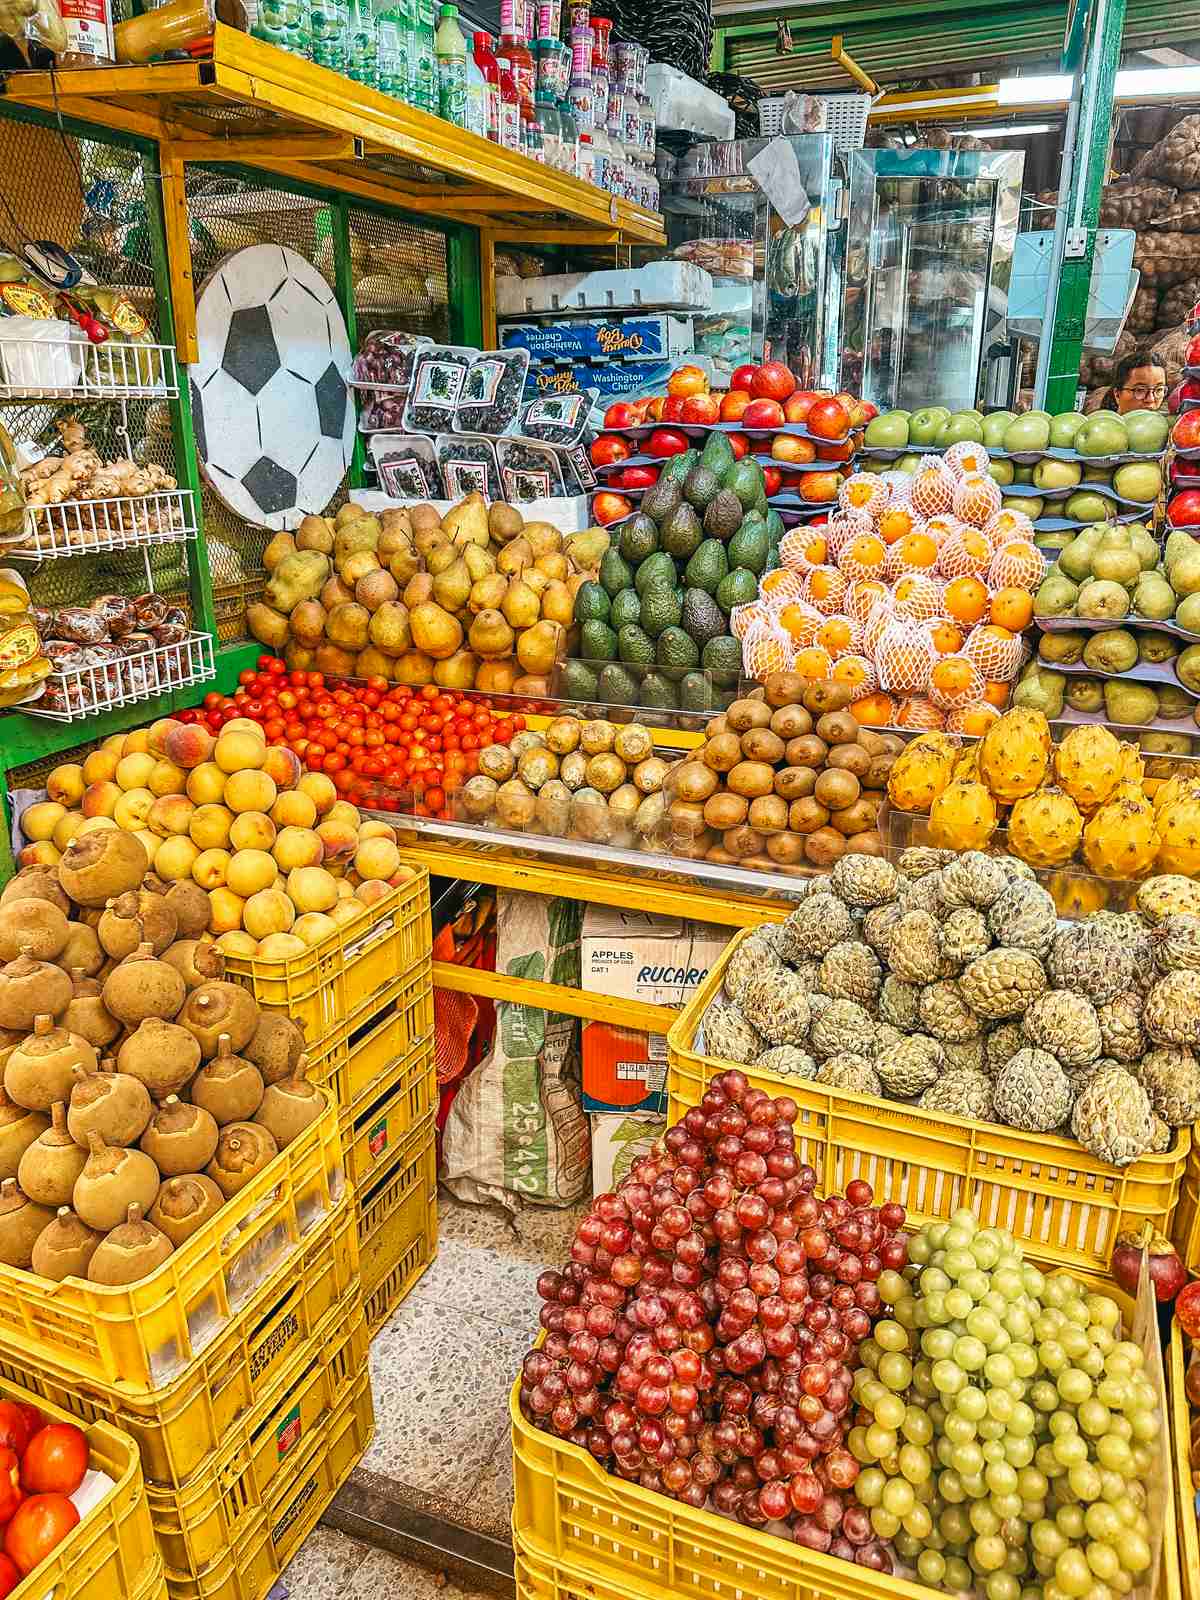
[667,930,1192,1272]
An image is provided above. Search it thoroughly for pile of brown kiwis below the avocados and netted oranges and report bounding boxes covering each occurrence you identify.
[664,672,904,874]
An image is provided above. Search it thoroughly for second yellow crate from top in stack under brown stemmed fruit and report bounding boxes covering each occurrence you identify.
[0,1189,358,1488]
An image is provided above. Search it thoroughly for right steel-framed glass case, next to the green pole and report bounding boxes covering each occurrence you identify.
[830,149,1024,411]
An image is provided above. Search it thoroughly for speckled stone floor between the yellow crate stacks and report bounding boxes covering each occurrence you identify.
[283,1189,582,1600]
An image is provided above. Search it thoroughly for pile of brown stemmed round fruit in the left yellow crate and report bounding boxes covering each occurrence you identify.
[0,829,325,1285]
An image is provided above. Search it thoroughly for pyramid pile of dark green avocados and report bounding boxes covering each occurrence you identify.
[560,434,784,710]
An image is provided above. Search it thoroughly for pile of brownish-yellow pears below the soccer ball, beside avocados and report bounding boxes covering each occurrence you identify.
[246,494,608,694]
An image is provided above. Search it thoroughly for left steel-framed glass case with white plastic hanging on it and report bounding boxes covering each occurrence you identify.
[662,133,840,387]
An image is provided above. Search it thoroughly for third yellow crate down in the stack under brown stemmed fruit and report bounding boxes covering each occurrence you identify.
[147,1294,370,1576]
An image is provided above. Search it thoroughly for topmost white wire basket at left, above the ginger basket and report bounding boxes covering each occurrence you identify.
[0,339,179,402]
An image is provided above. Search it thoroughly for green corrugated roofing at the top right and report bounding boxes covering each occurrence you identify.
[714,0,1197,94]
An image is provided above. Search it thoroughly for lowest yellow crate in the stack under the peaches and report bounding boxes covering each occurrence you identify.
[358,1114,437,1333]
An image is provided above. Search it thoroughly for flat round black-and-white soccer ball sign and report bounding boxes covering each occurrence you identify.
[189,245,355,531]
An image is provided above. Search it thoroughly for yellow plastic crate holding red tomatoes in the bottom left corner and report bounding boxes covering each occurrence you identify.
[0,1379,162,1600]
